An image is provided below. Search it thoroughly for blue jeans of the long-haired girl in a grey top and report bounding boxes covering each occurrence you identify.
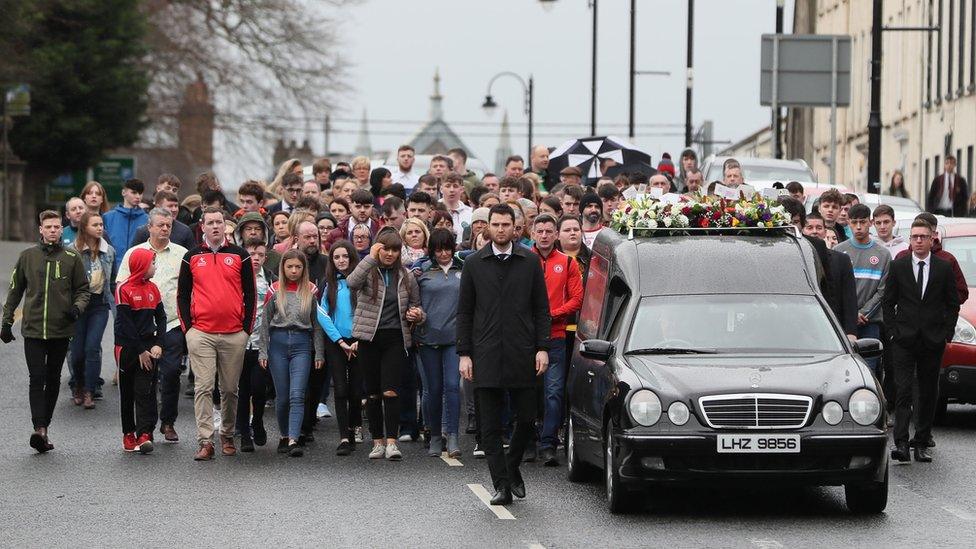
[268,328,312,440]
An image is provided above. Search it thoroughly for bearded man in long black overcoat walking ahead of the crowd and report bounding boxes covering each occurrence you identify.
[457,204,552,505]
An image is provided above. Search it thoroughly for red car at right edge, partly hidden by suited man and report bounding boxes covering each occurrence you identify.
[924,218,976,422]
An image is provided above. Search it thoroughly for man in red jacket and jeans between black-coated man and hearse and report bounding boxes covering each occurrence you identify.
[532,214,583,467]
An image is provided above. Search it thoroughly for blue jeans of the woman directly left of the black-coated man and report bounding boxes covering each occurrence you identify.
[419,345,461,437]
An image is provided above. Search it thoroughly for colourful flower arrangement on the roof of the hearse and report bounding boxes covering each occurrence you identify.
[610,194,791,234]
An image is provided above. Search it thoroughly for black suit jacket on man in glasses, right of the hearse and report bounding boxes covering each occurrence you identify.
[881,254,959,349]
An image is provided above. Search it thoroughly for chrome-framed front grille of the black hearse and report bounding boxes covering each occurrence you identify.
[698,393,813,429]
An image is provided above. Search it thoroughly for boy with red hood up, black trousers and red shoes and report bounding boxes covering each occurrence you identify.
[115,248,166,454]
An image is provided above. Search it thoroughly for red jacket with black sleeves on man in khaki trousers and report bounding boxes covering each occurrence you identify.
[176,239,257,334]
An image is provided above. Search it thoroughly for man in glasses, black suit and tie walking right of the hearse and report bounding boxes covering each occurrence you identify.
[882,219,959,462]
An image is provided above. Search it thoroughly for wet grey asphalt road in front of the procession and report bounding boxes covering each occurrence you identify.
[0,244,976,548]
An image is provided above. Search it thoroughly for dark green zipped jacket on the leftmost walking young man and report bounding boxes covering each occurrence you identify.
[3,241,89,339]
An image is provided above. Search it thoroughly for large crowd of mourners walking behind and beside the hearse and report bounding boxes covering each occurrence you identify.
[0,145,967,503]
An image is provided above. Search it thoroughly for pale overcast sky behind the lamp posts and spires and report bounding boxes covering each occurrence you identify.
[218,0,793,180]
